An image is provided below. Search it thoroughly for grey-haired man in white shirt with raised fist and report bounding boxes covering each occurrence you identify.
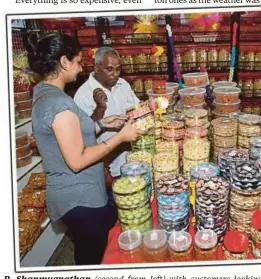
[74,47,139,180]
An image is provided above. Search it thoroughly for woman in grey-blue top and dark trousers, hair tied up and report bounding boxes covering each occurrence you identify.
[27,33,140,265]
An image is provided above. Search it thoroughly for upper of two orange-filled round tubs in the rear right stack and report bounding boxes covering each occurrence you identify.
[213,86,241,104]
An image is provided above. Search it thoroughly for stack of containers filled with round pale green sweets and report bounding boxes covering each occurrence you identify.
[112,176,152,233]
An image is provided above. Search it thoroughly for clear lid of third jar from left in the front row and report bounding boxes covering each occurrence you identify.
[168,231,192,252]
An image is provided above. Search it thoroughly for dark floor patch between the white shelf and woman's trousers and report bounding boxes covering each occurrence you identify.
[47,235,74,266]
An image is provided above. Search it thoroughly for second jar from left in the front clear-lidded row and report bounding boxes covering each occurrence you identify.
[143,230,168,263]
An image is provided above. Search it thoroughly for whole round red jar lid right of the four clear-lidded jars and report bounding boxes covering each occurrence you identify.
[221,231,249,253]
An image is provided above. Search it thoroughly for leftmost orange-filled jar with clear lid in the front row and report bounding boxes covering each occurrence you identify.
[118,230,143,263]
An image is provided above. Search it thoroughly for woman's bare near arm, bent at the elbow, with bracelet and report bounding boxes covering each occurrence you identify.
[52,110,140,172]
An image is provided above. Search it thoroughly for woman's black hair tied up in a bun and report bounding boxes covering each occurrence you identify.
[26,33,81,78]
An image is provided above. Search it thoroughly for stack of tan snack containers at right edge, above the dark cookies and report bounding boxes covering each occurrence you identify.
[238,114,261,149]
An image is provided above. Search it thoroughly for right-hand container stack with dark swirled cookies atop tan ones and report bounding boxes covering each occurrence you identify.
[229,162,261,235]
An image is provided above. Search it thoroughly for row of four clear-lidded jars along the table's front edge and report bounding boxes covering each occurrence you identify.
[118,229,217,263]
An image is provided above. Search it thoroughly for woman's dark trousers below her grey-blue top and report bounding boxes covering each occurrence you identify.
[61,195,118,265]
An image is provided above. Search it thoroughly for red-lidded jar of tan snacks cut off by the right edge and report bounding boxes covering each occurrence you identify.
[251,210,261,259]
